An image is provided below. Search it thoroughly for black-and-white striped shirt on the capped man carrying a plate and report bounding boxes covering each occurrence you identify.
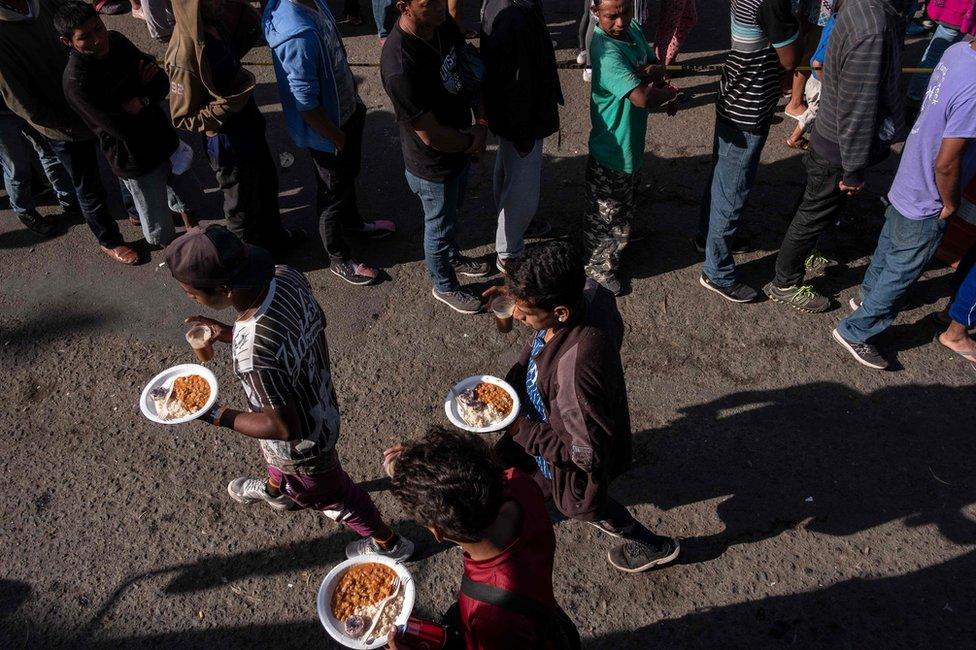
[234,266,339,474]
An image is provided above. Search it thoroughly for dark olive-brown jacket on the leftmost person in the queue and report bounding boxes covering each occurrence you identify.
[0,0,92,141]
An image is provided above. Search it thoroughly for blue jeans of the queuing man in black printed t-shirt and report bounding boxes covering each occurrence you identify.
[406,164,469,292]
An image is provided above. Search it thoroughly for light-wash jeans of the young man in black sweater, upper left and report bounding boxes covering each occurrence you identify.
[122,160,203,246]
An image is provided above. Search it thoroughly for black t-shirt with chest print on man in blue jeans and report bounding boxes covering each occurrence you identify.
[380,17,472,182]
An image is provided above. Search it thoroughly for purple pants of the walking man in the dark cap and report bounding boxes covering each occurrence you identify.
[268,465,383,537]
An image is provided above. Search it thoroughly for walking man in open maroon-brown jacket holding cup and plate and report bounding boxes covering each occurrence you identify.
[485,241,679,573]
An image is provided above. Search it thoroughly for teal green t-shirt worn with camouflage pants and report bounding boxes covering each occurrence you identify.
[590,21,656,174]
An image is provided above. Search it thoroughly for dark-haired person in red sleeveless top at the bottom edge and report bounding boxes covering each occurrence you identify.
[387,429,579,650]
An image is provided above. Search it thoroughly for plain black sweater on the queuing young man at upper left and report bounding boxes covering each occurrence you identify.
[63,32,179,178]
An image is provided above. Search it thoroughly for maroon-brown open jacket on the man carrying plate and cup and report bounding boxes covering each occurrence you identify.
[508,280,632,521]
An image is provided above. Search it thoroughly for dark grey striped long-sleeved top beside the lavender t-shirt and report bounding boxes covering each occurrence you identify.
[811,0,905,184]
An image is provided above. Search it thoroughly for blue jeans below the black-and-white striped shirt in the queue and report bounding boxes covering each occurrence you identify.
[698,119,769,287]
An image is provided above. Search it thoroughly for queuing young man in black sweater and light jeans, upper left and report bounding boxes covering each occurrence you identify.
[54,0,203,246]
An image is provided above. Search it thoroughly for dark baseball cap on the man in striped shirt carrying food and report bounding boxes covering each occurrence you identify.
[166,224,274,289]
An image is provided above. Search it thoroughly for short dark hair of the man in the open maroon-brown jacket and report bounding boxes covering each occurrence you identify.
[505,241,586,309]
